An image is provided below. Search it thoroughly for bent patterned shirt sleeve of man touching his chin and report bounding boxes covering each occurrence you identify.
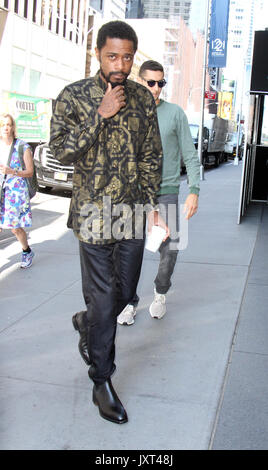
[49,88,106,165]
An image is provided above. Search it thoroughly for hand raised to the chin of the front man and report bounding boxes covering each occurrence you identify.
[98,83,126,118]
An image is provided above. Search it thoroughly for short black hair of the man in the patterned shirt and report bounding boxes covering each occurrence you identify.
[97,21,138,52]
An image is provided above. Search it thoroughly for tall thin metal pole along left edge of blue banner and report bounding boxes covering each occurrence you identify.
[198,0,210,181]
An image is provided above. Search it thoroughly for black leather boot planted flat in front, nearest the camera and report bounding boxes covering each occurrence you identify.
[93,378,128,424]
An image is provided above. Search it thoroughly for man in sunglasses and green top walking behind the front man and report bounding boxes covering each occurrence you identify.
[117,60,200,325]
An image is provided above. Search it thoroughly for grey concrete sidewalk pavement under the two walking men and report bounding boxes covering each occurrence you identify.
[0,163,268,450]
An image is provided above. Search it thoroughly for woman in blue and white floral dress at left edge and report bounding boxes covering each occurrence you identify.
[0,114,34,268]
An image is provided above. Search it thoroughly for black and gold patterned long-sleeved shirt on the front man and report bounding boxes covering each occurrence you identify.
[49,73,162,244]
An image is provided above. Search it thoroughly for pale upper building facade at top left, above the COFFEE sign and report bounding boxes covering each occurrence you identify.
[0,0,90,98]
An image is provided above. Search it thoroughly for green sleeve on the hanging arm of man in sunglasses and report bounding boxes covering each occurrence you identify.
[177,109,200,195]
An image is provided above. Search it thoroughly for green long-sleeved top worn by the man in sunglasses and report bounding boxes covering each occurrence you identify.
[157,100,200,195]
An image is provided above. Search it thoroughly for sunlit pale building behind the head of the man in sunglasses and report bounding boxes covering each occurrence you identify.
[126,17,204,111]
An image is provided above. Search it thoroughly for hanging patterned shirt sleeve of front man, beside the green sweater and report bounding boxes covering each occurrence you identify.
[138,103,163,207]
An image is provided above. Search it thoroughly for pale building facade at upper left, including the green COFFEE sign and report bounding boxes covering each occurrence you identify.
[0,0,90,145]
